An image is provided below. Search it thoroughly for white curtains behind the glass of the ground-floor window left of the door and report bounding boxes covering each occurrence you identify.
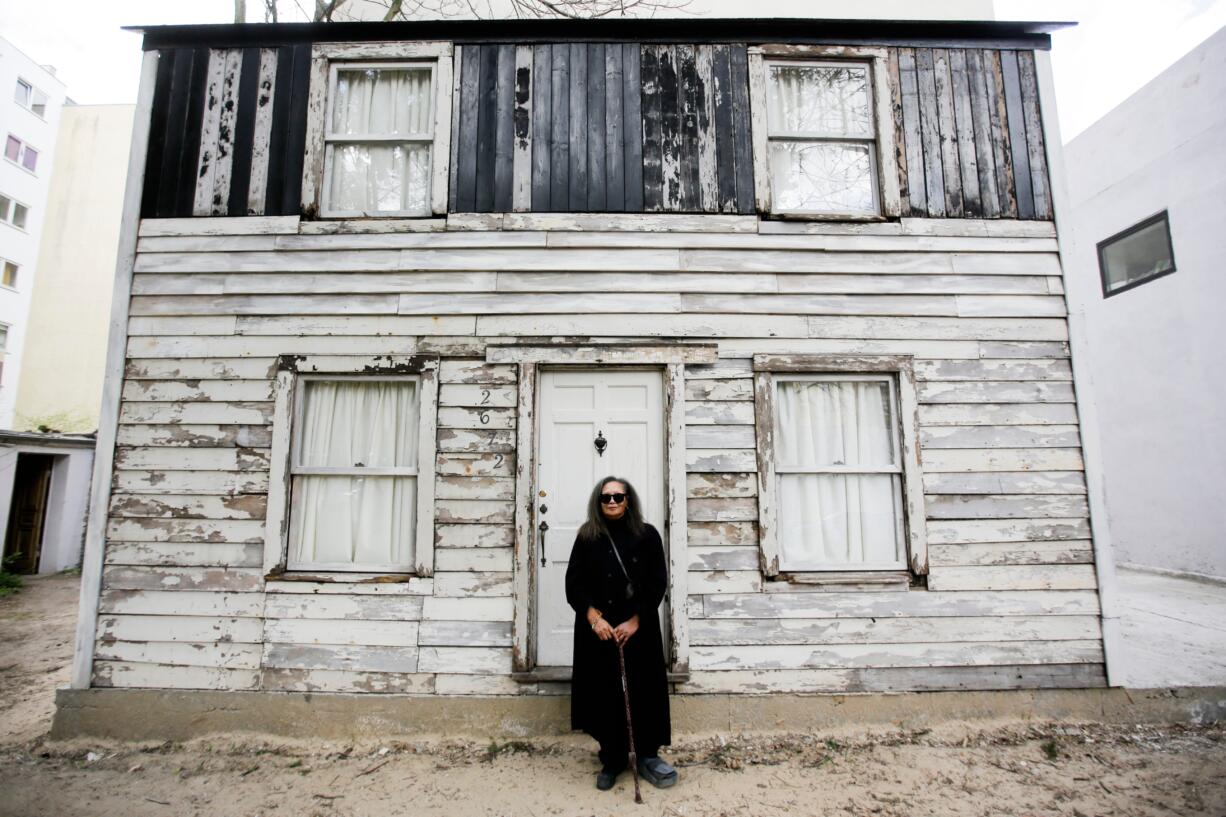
[291,380,418,566]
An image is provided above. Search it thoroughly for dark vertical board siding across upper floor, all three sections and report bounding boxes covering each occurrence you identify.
[141,43,1052,220]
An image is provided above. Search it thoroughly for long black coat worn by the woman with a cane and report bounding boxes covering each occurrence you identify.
[566,521,672,751]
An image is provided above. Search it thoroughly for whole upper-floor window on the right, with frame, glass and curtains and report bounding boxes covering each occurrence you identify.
[749,45,901,220]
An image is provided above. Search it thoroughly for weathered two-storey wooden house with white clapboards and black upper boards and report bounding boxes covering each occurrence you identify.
[62,20,1107,721]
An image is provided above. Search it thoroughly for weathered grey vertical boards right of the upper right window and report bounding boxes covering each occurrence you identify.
[890,48,1052,220]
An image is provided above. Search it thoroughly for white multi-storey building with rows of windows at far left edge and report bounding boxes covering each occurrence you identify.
[0,38,65,429]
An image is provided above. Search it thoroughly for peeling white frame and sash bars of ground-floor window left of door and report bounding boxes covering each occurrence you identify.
[264,356,439,581]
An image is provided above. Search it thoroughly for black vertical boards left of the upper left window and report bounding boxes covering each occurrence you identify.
[141,44,311,218]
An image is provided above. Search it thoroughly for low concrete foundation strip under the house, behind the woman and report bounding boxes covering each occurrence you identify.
[50,687,1226,741]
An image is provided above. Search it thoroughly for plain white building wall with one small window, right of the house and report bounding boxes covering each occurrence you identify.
[1065,23,1226,577]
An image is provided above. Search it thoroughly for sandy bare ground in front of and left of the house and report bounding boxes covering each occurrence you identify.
[0,577,1226,817]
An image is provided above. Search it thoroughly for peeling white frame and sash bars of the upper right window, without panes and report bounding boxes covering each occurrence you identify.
[749,44,902,221]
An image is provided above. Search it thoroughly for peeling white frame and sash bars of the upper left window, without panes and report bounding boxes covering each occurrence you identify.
[302,42,455,218]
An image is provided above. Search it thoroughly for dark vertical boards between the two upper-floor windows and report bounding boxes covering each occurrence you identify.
[449,43,754,213]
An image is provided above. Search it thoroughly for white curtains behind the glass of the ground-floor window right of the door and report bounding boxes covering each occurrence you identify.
[775,380,901,569]
